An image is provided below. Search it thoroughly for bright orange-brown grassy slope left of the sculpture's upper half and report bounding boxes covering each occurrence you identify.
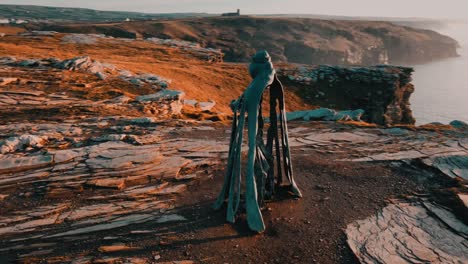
[0,31,311,113]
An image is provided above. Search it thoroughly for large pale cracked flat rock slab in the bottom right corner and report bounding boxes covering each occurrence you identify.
[346,202,468,264]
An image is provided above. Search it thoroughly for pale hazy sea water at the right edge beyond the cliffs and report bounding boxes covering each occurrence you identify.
[410,23,468,125]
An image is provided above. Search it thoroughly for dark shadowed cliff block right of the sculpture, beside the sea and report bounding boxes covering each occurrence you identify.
[278,65,415,125]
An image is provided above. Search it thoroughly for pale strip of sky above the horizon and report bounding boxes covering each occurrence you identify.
[0,0,468,19]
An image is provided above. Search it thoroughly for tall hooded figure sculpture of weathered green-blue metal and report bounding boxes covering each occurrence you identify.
[213,51,302,232]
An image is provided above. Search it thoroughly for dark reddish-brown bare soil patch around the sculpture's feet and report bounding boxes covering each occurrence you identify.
[155,153,423,263]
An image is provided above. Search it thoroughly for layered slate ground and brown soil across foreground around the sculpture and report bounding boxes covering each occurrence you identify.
[0,106,468,263]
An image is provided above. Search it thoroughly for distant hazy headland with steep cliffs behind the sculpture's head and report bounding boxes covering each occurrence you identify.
[27,16,458,65]
